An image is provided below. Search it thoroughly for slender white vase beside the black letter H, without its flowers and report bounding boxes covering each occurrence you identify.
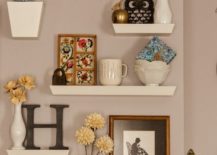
[11,103,26,150]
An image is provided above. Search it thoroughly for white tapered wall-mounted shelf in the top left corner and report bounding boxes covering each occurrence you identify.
[7,0,44,38]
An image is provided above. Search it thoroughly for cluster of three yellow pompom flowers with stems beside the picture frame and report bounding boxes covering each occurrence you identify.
[75,113,114,155]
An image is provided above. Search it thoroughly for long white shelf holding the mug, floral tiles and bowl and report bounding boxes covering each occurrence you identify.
[50,85,176,96]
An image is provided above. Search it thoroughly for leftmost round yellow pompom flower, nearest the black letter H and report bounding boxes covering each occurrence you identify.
[75,127,95,145]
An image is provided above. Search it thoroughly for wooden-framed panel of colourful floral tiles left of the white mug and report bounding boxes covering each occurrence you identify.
[58,34,97,85]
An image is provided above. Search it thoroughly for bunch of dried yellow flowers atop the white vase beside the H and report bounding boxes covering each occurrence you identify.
[4,75,35,104]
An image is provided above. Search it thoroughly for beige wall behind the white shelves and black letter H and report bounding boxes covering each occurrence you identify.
[0,0,184,155]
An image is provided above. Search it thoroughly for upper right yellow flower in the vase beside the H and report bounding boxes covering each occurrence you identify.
[18,75,35,90]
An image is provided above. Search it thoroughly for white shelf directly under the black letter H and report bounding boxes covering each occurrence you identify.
[7,150,69,155]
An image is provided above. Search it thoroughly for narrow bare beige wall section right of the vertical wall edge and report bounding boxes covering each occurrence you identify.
[184,0,217,155]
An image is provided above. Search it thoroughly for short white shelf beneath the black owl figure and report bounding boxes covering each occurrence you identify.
[113,24,175,34]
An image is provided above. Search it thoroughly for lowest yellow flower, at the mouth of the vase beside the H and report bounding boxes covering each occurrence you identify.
[10,88,26,104]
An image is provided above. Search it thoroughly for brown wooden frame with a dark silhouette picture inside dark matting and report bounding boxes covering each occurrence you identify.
[109,115,170,155]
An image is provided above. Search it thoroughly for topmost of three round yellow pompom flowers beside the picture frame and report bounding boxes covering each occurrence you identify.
[84,113,105,129]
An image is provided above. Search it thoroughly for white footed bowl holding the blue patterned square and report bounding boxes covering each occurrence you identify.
[134,60,170,86]
